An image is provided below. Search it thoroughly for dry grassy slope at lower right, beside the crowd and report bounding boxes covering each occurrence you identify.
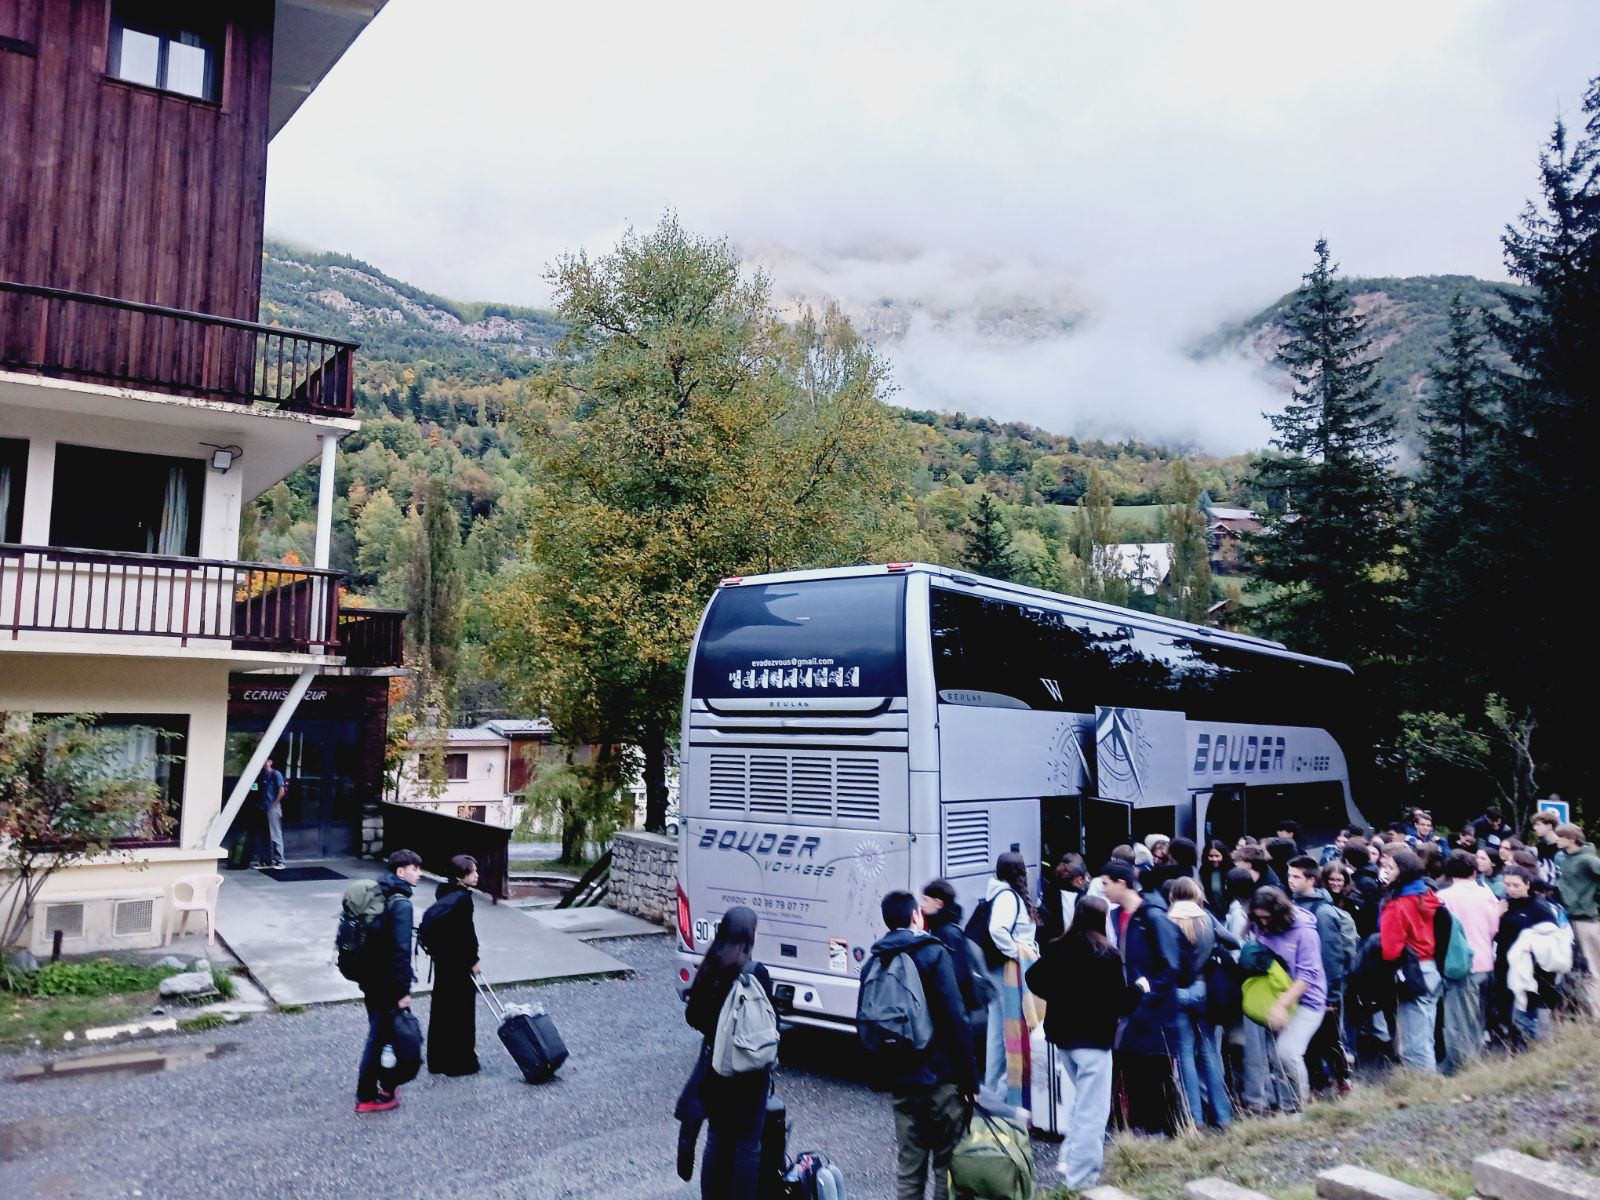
[1046,1021,1600,1200]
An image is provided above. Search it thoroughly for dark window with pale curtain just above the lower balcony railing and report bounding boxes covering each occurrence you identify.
[50,445,205,558]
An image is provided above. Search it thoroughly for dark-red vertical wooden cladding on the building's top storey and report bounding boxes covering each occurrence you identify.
[0,0,272,320]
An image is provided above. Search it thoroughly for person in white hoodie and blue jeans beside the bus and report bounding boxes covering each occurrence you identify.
[984,850,1038,1109]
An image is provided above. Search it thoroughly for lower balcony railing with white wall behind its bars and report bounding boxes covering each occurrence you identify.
[0,542,339,654]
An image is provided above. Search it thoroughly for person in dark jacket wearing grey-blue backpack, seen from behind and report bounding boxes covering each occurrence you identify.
[856,891,978,1200]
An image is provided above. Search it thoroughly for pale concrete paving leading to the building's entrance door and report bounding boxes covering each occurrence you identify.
[216,859,624,1005]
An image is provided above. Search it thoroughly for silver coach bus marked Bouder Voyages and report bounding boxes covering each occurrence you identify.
[677,563,1360,1027]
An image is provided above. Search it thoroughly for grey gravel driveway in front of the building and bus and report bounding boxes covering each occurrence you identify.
[0,938,1054,1200]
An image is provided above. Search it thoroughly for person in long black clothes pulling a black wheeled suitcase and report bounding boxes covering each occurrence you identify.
[416,854,478,1075]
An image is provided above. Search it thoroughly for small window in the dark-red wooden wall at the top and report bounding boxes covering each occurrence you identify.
[106,0,222,104]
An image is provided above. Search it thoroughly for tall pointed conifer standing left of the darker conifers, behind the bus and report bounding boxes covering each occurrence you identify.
[1251,238,1395,662]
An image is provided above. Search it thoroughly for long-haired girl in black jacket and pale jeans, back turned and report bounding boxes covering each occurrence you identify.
[1027,896,1142,1192]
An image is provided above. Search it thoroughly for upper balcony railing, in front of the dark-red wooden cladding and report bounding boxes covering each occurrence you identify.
[0,280,355,416]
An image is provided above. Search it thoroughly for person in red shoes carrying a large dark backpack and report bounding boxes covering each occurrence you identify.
[355,850,422,1112]
